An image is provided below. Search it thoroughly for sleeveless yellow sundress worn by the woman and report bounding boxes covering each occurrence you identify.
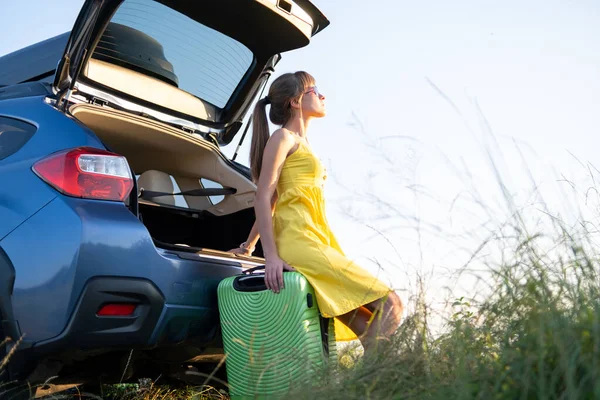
[273,143,391,341]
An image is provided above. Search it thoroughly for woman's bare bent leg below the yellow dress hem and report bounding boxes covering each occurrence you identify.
[337,292,402,352]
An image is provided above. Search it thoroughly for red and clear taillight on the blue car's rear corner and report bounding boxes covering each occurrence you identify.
[33,147,133,201]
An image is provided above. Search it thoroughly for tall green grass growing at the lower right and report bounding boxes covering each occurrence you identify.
[282,216,600,400]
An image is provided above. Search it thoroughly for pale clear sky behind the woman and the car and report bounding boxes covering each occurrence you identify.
[0,0,600,324]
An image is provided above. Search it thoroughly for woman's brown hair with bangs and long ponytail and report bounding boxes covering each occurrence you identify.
[250,71,315,183]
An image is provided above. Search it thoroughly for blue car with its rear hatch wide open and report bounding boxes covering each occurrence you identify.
[0,0,329,397]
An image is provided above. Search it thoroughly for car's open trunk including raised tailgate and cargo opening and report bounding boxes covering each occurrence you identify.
[59,0,329,257]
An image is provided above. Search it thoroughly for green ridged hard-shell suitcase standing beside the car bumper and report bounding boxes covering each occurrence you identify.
[218,266,337,399]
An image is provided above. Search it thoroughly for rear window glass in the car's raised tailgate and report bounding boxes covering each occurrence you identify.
[93,0,254,108]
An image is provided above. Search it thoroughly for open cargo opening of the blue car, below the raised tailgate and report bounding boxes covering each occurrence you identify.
[69,103,262,262]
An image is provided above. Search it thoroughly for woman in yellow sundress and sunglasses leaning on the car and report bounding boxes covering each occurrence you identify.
[231,71,402,352]
